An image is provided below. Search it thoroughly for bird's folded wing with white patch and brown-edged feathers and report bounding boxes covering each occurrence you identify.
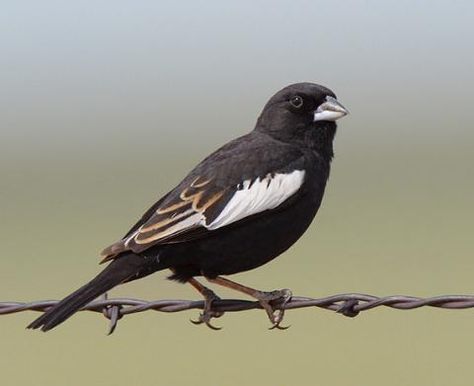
[101,133,305,261]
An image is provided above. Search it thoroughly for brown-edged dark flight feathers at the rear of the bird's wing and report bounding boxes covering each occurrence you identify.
[101,177,232,263]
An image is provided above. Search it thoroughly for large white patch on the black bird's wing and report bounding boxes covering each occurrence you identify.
[208,170,305,230]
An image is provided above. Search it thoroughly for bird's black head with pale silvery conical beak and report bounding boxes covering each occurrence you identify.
[255,83,349,157]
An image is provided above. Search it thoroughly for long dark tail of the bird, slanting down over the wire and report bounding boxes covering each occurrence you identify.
[27,253,156,331]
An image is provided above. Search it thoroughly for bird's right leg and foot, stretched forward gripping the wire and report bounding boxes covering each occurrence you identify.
[207,276,292,330]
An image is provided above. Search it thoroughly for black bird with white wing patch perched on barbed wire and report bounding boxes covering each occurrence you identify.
[28,83,348,331]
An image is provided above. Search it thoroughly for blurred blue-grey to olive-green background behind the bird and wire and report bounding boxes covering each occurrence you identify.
[0,0,474,386]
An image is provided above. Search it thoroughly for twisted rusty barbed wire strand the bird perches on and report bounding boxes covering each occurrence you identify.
[0,293,474,334]
